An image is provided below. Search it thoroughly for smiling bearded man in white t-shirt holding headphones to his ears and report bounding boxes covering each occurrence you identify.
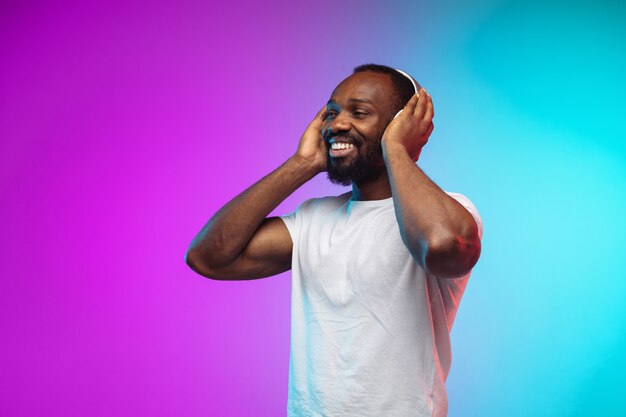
[187,64,482,417]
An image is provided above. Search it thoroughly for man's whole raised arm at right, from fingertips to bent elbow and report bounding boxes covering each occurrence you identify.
[382,89,480,278]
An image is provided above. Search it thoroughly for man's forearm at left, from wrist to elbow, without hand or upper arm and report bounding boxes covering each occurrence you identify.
[187,156,317,265]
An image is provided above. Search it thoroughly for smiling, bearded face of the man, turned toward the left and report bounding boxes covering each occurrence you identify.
[322,72,395,185]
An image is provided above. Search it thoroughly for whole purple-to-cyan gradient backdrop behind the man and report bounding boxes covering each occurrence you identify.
[0,0,626,417]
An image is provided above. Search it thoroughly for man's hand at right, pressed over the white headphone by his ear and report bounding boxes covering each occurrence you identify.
[382,88,435,161]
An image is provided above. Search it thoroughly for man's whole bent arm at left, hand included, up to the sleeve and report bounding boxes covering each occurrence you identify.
[186,108,327,280]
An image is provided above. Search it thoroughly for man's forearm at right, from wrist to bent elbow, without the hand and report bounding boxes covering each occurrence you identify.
[383,141,480,276]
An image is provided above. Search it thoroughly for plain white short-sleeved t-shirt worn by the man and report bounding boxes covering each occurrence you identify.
[281,193,482,417]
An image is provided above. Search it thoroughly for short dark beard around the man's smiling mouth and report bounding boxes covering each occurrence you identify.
[326,136,385,186]
